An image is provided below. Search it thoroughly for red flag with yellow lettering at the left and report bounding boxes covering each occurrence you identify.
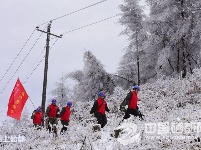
[7,78,28,120]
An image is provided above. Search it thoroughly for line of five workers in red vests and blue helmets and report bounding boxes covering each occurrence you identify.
[31,85,143,134]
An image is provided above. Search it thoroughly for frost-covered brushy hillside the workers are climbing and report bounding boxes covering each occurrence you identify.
[0,70,201,150]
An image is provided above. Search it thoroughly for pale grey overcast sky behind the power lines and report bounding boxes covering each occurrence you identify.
[0,0,148,124]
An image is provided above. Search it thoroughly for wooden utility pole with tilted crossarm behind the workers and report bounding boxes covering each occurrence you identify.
[36,21,62,125]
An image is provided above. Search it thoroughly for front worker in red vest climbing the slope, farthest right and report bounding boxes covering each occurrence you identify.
[123,85,143,119]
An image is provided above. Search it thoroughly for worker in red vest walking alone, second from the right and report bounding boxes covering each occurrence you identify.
[90,91,110,128]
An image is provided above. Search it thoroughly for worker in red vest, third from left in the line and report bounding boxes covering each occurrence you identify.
[59,101,72,134]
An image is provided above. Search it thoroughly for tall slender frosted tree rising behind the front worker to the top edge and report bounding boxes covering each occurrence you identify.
[118,0,147,84]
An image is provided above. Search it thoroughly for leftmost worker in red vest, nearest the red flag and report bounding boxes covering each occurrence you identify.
[31,106,43,127]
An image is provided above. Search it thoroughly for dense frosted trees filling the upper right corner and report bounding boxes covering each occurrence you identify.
[147,0,201,77]
